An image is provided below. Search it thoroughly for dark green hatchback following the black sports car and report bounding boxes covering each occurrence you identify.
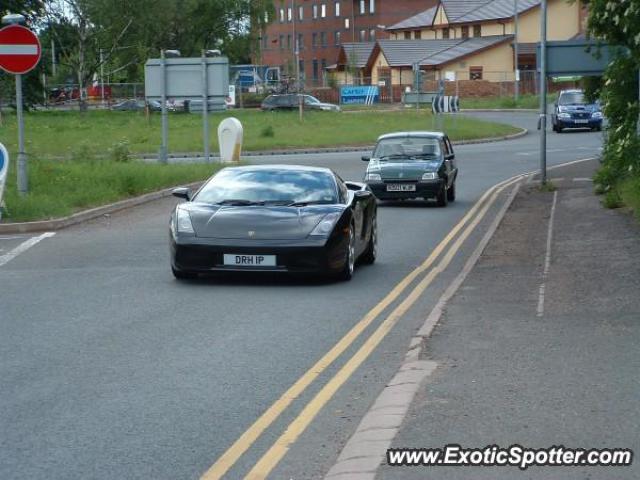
[362,132,458,207]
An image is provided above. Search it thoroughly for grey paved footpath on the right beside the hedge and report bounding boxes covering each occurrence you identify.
[370,162,640,480]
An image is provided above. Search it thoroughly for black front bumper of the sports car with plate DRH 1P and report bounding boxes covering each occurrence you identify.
[170,235,349,273]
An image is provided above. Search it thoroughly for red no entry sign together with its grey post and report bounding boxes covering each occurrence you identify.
[0,15,42,195]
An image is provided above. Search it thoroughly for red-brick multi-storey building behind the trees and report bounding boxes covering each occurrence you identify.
[255,0,438,86]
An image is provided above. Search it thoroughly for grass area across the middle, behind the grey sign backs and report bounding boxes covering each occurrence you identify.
[0,110,518,159]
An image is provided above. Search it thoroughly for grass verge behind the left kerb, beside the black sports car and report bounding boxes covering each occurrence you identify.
[2,157,219,222]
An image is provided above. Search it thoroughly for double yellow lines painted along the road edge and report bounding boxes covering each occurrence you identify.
[201,175,522,480]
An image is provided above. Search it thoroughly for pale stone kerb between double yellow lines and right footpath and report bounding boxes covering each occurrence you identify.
[325,178,522,480]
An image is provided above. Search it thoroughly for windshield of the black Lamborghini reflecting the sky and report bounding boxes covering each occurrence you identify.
[194,168,337,205]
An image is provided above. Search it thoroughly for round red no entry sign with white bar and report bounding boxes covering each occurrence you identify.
[0,25,42,74]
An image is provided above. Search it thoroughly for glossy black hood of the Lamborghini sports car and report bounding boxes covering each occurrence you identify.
[181,203,336,240]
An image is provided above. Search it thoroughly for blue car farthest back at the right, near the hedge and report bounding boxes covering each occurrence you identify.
[551,90,604,133]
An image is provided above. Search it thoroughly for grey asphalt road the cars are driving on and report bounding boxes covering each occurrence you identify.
[0,113,602,479]
